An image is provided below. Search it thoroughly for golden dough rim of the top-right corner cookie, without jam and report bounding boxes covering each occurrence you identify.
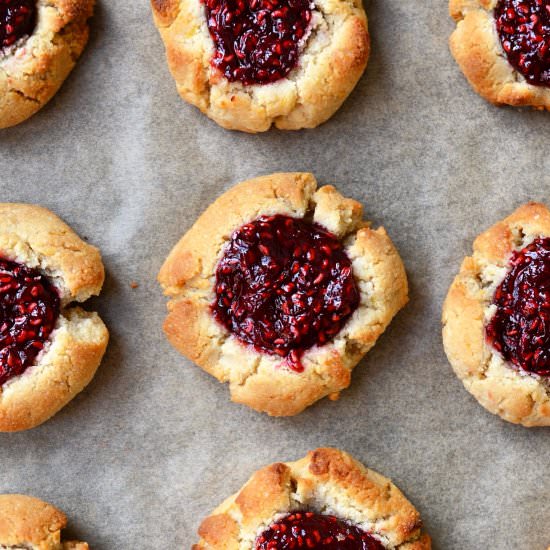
[449,0,550,109]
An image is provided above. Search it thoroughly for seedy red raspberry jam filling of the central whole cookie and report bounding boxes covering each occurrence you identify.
[212,215,359,372]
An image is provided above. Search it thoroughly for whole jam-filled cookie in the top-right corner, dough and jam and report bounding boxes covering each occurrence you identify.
[449,0,550,109]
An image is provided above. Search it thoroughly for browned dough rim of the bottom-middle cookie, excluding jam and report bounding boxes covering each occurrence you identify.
[193,448,431,550]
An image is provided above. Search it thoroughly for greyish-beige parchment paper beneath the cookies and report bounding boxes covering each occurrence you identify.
[0,0,550,550]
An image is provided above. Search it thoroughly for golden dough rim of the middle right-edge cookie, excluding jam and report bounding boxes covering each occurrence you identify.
[443,203,550,426]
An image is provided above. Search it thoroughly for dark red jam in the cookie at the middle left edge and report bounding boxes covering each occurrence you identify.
[0,259,59,385]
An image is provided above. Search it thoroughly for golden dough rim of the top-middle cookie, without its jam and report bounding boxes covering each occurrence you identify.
[151,0,370,133]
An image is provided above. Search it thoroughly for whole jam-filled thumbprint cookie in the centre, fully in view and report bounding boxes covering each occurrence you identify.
[158,173,408,416]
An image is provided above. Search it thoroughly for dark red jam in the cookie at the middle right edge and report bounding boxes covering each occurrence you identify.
[486,238,550,376]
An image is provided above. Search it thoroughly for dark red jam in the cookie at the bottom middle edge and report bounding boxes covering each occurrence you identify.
[255,512,384,550]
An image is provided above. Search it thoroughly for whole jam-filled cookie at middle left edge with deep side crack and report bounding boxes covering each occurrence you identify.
[0,203,108,432]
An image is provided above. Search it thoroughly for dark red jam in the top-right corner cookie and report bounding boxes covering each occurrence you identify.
[495,0,550,86]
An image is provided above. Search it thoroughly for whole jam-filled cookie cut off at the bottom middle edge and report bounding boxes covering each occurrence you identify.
[193,448,431,550]
